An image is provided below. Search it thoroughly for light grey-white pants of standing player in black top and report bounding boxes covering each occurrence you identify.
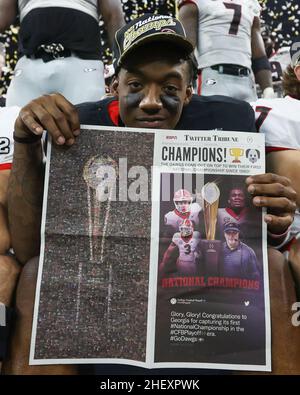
[6,55,105,107]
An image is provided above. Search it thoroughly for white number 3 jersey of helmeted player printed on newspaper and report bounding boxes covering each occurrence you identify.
[172,232,200,263]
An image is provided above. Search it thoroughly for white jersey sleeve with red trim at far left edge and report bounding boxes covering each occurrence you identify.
[0,107,20,170]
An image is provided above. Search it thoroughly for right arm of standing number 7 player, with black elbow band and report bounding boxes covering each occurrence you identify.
[251,16,274,98]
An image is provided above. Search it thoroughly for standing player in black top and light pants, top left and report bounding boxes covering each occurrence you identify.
[0,0,125,106]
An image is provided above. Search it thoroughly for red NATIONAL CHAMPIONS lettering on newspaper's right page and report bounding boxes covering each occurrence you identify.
[161,276,260,291]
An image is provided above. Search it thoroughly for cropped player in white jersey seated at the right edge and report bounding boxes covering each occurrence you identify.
[252,38,300,298]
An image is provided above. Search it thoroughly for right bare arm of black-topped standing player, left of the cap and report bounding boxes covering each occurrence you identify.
[98,0,125,48]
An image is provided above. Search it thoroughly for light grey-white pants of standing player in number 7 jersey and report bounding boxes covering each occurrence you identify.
[198,67,257,102]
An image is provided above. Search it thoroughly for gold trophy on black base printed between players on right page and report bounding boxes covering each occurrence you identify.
[201,182,222,276]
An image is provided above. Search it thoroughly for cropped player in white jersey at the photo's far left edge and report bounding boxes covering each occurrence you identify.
[0,107,20,371]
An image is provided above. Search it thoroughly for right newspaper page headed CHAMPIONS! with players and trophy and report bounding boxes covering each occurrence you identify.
[151,131,270,370]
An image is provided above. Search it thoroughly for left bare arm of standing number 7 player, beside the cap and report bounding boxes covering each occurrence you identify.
[179,1,198,47]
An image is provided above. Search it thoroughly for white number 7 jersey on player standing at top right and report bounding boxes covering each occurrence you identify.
[179,0,261,69]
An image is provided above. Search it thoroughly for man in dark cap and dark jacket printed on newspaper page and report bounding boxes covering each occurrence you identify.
[221,222,259,280]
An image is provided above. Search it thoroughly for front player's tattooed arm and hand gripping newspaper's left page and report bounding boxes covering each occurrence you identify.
[8,94,80,264]
